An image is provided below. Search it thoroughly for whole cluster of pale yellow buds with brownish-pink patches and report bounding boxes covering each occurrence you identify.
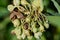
[8,0,49,40]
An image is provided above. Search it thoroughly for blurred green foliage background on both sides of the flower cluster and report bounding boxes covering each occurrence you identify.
[0,0,60,40]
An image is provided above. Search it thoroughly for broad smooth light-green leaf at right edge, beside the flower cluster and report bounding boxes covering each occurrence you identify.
[47,16,60,32]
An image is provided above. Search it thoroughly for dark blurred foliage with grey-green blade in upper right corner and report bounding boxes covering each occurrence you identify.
[43,0,60,15]
